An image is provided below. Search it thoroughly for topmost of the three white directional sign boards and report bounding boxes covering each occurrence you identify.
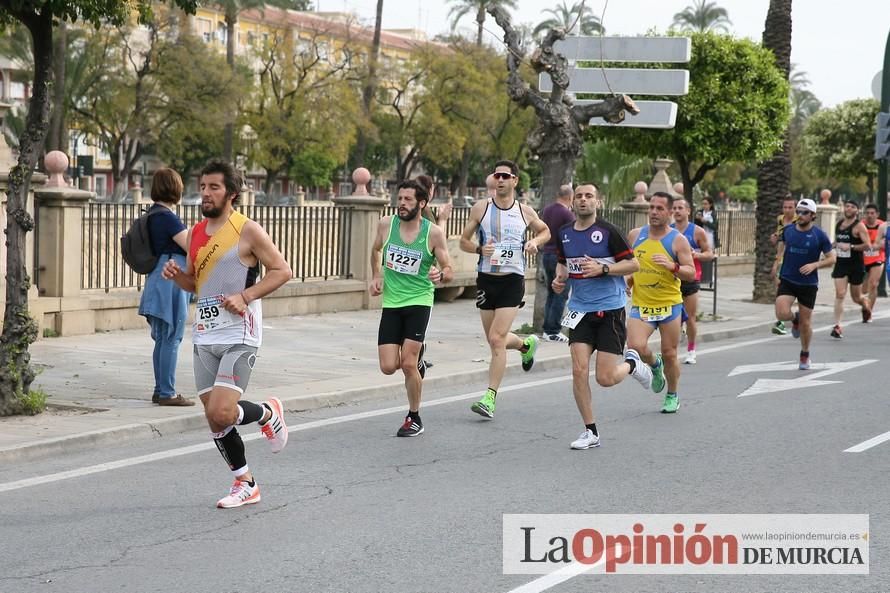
[553,36,692,64]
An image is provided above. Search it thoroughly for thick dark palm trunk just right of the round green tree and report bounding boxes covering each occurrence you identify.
[752,0,791,303]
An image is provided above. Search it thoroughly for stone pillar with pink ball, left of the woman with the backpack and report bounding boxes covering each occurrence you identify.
[34,151,95,300]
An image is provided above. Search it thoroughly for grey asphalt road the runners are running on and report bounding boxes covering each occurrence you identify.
[0,320,890,593]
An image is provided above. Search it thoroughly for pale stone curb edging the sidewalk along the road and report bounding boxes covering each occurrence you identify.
[0,312,848,463]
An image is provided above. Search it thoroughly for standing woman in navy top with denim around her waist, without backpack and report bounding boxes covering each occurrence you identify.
[139,168,195,406]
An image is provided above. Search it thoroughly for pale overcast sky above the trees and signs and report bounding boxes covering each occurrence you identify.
[314,0,890,106]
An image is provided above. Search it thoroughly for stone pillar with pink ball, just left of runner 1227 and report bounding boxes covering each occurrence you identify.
[333,167,388,309]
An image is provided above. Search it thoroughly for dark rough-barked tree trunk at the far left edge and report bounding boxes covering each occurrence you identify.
[0,10,53,416]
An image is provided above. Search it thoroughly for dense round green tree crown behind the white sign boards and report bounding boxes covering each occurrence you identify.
[588,33,790,194]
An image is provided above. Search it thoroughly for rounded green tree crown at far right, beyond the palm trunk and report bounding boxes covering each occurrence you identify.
[803,99,880,179]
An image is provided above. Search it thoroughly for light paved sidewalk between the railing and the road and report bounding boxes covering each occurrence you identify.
[0,270,860,463]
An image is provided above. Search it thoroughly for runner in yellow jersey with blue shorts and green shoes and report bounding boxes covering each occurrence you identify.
[627,192,695,414]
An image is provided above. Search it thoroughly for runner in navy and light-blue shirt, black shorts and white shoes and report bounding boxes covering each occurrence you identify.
[553,183,652,449]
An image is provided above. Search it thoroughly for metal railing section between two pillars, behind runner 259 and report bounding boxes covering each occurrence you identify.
[81,202,353,292]
